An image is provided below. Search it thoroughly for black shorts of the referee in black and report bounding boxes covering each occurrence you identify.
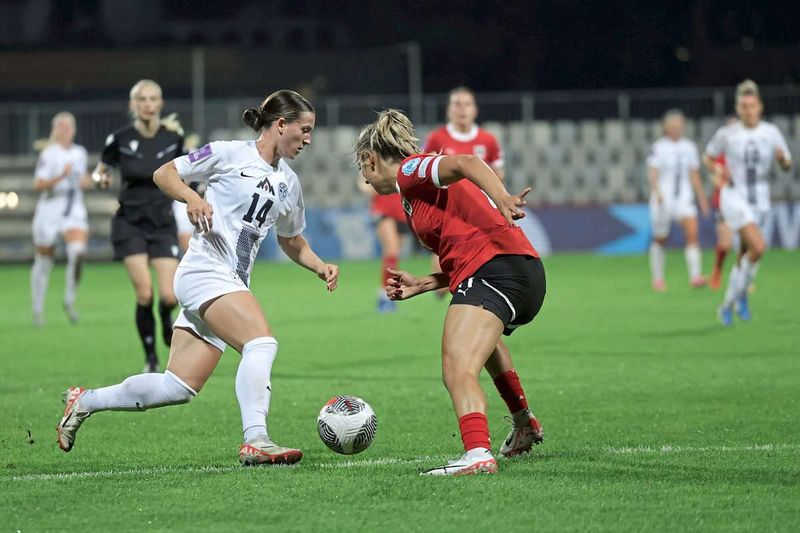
[111,207,180,261]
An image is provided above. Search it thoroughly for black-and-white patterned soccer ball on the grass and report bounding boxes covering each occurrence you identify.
[317,396,378,455]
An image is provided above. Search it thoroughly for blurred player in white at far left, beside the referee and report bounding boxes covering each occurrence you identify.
[31,111,91,326]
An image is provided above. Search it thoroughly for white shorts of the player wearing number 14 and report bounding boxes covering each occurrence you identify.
[173,265,250,351]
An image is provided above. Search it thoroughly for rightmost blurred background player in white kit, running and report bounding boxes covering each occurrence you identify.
[703,80,792,326]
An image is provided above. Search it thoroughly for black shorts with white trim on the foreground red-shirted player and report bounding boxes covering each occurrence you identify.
[450,255,547,335]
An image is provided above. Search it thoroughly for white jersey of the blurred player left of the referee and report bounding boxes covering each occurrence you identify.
[34,143,89,217]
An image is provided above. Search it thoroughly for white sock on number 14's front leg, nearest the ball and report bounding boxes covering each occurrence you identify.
[236,337,278,442]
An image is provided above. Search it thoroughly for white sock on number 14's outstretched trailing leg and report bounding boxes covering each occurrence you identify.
[80,370,197,413]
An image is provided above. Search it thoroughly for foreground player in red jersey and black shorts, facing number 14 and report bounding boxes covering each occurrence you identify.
[355,110,545,475]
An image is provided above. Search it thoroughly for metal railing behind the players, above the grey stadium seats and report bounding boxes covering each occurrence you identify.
[0,87,800,155]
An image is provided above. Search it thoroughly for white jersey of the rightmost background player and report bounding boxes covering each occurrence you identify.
[706,121,791,211]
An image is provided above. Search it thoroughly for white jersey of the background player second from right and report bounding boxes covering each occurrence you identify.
[647,137,700,204]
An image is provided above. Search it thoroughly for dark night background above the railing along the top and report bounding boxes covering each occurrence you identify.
[0,0,800,98]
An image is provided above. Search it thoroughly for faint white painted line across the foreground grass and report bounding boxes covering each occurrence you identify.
[7,444,800,481]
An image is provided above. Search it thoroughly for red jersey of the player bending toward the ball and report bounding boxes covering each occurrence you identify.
[397,154,539,292]
